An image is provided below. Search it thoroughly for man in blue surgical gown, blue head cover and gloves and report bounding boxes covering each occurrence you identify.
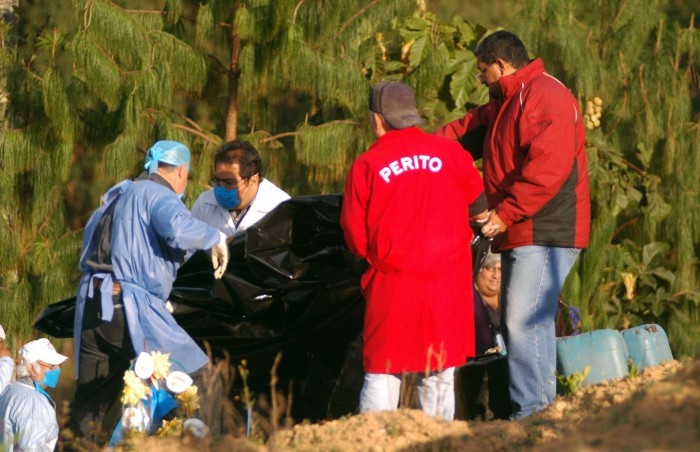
[68,141,228,438]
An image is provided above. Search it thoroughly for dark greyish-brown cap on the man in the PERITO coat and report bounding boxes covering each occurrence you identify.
[369,82,423,129]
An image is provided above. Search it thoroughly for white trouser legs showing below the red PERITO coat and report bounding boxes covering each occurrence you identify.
[360,367,455,421]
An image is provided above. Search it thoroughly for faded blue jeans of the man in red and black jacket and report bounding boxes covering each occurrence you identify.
[501,246,581,419]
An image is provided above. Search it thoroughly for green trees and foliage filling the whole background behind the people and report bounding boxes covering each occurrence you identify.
[0,0,700,354]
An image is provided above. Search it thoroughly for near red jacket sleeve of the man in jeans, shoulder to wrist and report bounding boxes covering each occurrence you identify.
[496,93,581,226]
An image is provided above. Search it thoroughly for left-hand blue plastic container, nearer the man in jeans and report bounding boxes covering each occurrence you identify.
[557,329,629,385]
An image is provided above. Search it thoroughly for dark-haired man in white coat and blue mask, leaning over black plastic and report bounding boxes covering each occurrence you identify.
[192,141,289,237]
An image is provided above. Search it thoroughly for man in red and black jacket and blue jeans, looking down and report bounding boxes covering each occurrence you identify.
[437,31,590,419]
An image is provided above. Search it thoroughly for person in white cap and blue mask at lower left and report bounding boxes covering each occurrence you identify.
[0,339,68,452]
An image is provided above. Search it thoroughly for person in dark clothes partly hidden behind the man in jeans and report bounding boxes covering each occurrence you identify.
[460,252,513,420]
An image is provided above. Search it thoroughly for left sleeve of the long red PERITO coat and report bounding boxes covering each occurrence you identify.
[340,160,370,258]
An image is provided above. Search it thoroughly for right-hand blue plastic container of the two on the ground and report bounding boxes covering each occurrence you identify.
[622,323,673,369]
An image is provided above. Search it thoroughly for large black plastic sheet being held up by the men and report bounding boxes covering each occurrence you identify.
[34,195,366,420]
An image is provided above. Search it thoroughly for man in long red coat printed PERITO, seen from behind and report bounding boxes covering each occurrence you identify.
[340,82,487,419]
